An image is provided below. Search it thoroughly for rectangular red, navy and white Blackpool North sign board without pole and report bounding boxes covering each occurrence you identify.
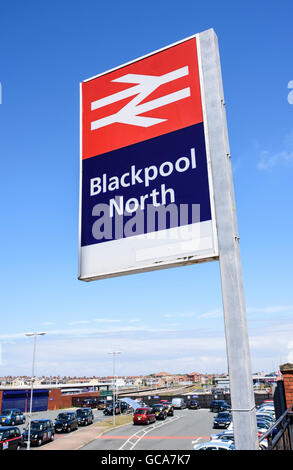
[79,35,218,281]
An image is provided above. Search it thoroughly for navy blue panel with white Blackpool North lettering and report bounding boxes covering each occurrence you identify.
[81,123,211,246]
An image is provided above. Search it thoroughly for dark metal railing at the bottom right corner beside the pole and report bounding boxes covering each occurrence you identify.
[259,405,293,450]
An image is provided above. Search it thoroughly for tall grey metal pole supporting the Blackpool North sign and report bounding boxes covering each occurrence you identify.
[198,29,258,450]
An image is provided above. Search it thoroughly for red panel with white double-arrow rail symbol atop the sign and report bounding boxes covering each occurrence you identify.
[82,38,203,159]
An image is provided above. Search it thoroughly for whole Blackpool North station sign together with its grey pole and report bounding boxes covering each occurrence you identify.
[79,29,258,449]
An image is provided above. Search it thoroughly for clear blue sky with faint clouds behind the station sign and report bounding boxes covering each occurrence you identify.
[0,0,293,376]
